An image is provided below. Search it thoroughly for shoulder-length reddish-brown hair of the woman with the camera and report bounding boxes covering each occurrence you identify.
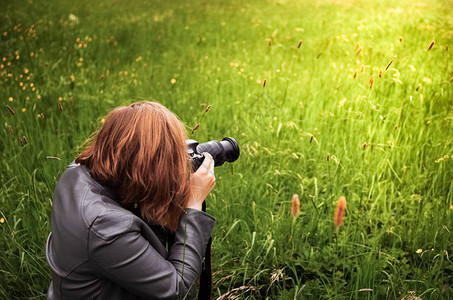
[76,101,190,231]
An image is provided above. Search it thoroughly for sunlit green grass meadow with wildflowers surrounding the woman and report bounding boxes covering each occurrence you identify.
[0,0,453,300]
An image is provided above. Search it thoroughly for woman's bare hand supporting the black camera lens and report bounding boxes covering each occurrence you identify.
[187,152,215,210]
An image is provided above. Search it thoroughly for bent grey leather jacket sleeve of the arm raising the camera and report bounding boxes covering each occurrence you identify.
[89,209,215,299]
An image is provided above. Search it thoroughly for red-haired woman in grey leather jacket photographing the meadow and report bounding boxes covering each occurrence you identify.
[46,102,215,299]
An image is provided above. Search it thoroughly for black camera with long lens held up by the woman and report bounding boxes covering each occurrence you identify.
[186,137,239,171]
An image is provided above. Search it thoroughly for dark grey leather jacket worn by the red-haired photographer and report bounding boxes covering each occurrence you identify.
[46,163,215,300]
